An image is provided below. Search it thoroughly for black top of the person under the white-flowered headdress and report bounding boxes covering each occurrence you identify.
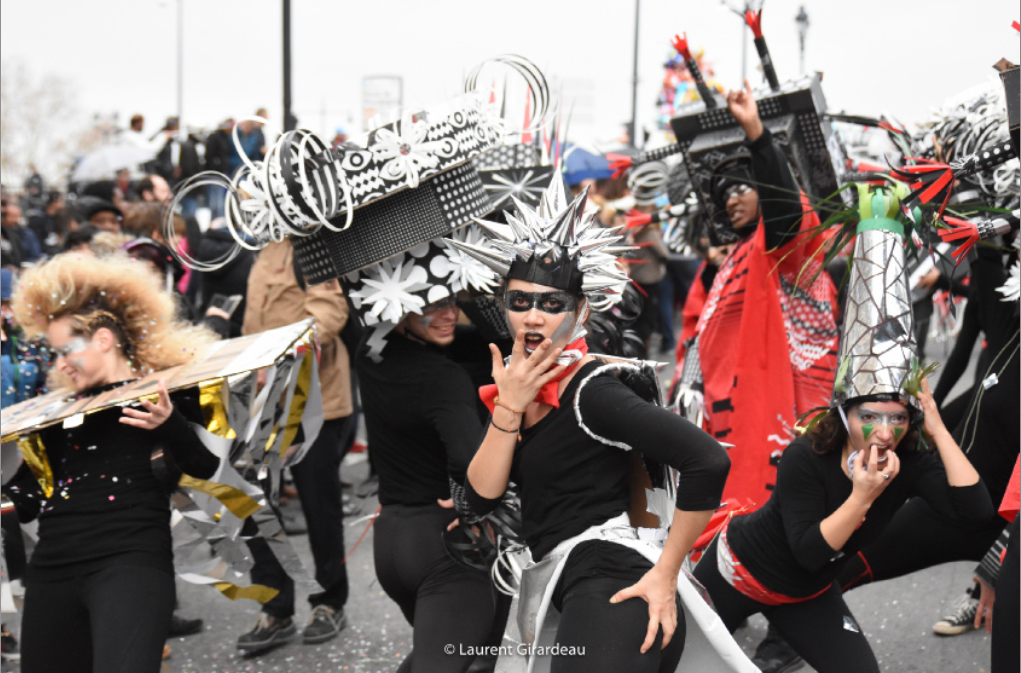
[358,331,482,506]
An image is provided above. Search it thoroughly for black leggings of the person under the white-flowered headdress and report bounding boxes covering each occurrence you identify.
[373,504,496,673]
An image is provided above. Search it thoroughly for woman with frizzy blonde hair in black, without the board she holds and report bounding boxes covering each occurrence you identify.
[3,254,218,673]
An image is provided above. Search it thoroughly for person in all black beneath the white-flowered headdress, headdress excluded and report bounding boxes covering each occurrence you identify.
[358,298,495,673]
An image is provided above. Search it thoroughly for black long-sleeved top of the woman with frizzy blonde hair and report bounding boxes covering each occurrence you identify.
[3,384,220,581]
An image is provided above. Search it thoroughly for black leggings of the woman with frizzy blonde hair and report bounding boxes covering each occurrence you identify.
[21,565,175,673]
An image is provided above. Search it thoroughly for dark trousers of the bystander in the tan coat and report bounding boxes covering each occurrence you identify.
[248,416,353,619]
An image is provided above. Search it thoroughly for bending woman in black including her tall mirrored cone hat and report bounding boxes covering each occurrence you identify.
[695,183,992,673]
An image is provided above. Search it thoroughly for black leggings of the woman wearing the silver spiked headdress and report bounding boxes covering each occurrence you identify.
[550,542,685,673]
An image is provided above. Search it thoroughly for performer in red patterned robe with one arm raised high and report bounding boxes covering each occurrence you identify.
[695,82,838,506]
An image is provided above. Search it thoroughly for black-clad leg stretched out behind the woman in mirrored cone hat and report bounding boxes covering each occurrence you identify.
[837,497,1007,591]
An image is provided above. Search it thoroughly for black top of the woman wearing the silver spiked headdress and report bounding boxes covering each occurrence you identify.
[466,360,730,561]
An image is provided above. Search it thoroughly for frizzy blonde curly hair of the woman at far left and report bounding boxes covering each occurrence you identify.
[12,252,218,375]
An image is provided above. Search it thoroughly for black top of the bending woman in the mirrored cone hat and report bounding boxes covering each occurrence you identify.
[726,437,994,597]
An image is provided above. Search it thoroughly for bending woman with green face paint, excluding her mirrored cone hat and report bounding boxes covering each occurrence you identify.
[695,381,992,673]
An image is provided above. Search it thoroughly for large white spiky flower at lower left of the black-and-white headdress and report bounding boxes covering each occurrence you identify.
[351,254,429,325]
